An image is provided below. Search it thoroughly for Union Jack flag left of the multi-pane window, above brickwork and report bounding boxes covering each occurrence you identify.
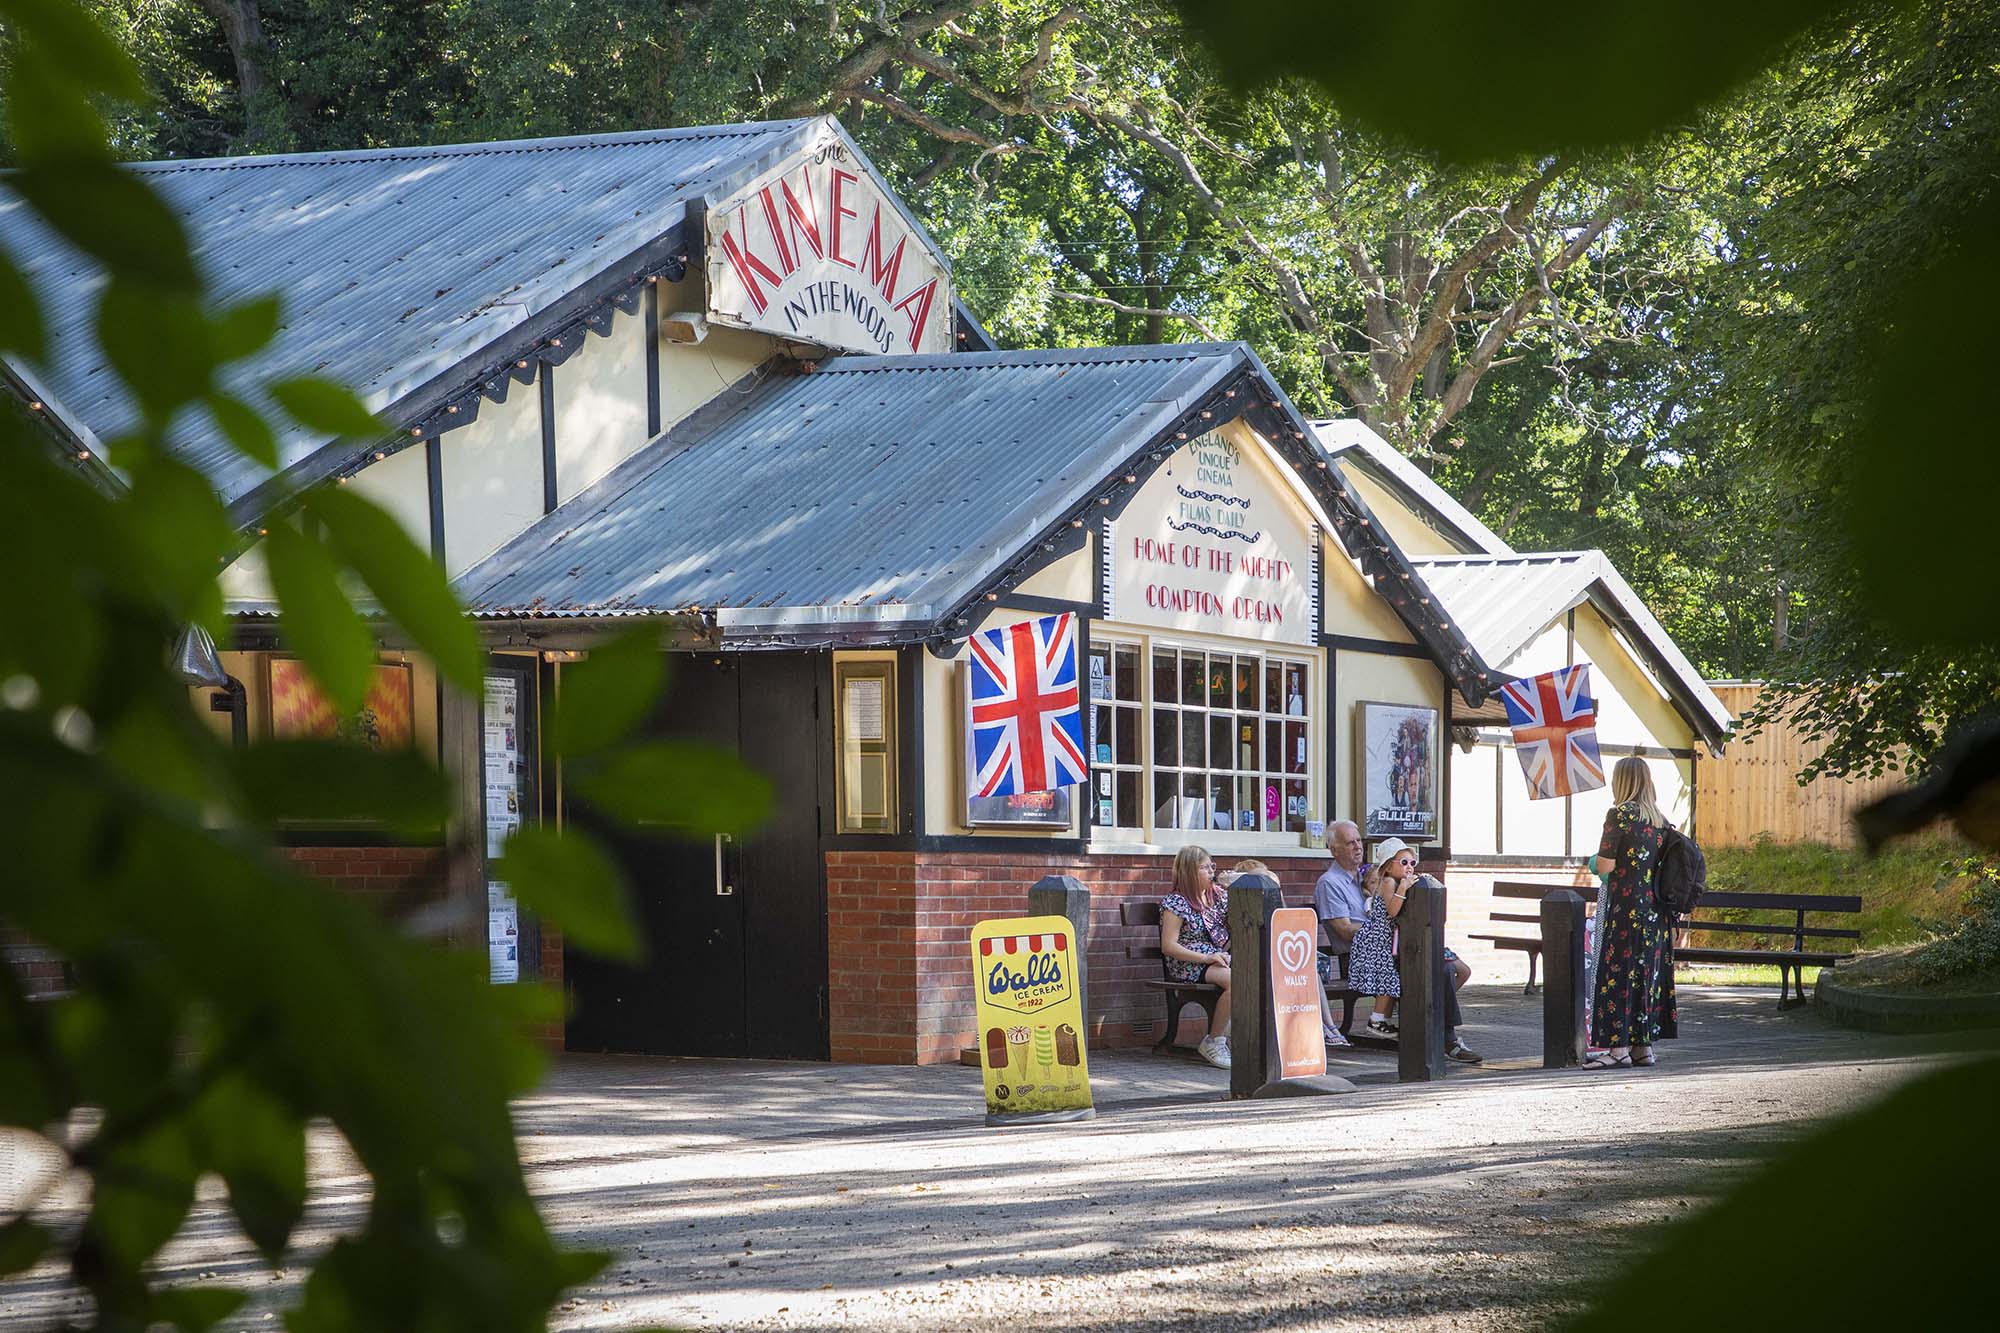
[966,612,1090,797]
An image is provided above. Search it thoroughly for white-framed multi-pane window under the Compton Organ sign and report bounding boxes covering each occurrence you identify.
[1090,640,1312,833]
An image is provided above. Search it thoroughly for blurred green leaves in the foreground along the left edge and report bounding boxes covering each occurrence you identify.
[0,0,758,1333]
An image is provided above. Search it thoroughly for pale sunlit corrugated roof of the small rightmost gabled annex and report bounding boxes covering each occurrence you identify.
[1410,550,1732,745]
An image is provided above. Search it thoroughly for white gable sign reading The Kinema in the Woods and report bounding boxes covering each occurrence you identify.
[708,138,952,354]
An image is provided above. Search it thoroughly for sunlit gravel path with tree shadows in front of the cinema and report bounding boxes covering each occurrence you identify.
[0,987,1952,1331]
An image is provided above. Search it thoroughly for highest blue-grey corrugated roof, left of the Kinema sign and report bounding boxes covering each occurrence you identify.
[0,120,818,500]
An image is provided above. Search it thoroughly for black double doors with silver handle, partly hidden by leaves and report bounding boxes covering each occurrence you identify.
[566,652,828,1059]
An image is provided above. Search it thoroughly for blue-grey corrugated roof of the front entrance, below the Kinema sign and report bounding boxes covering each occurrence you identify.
[458,344,1248,616]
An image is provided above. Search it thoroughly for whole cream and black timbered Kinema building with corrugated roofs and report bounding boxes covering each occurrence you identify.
[0,118,1714,1063]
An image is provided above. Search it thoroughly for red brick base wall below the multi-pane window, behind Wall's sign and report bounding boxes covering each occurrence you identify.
[826,851,1326,1065]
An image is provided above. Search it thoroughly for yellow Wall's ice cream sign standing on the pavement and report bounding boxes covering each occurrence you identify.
[972,917,1094,1125]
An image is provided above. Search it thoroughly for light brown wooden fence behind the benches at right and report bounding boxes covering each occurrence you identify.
[1694,683,1902,847]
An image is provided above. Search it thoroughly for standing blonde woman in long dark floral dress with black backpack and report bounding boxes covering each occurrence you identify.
[1584,757,1674,1069]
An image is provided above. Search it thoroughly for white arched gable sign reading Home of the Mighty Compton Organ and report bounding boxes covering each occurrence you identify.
[1106,432,1320,644]
